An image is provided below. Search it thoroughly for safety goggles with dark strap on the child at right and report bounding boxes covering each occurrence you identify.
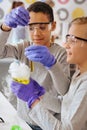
[66,34,87,44]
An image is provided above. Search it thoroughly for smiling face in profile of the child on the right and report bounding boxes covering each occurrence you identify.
[65,24,87,66]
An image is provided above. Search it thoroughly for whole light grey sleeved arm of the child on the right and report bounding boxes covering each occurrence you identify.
[30,82,87,130]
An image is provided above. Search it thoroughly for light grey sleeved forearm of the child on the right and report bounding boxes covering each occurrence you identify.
[29,102,60,130]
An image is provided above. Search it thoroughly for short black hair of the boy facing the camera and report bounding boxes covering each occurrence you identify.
[27,1,54,22]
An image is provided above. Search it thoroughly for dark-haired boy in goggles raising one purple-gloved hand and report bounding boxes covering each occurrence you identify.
[0,2,70,130]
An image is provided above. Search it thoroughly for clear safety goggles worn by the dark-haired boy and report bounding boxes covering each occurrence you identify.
[29,22,51,32]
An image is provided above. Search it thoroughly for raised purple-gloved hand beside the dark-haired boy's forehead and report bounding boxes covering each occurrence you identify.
[4,6,29,28]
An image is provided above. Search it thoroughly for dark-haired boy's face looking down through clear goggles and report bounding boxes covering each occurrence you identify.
[29,12,55,47]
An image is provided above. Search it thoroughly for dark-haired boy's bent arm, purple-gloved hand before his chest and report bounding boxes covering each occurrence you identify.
[25,45,70,95]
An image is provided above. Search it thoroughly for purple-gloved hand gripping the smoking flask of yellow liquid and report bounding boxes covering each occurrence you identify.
[11,78,45,108]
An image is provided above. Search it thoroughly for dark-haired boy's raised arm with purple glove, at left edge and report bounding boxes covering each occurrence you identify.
[0,7,29,58]
